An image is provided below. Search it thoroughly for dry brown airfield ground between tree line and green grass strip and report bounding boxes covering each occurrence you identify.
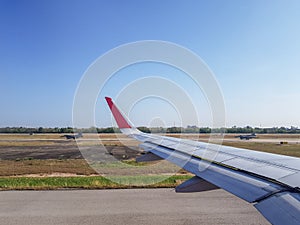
[0,134,300,180]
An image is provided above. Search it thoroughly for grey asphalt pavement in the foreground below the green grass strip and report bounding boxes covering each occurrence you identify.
[0,189,269,225]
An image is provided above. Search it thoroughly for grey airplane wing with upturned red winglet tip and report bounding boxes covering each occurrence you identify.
[106,97,300,225]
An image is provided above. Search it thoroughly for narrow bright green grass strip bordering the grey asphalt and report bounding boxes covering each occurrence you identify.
[0,175,192,190]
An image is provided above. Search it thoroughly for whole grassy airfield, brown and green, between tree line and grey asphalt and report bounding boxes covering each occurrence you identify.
[0,134,300,190]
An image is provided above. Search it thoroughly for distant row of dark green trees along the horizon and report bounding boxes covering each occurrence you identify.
[0,126,300,134]
